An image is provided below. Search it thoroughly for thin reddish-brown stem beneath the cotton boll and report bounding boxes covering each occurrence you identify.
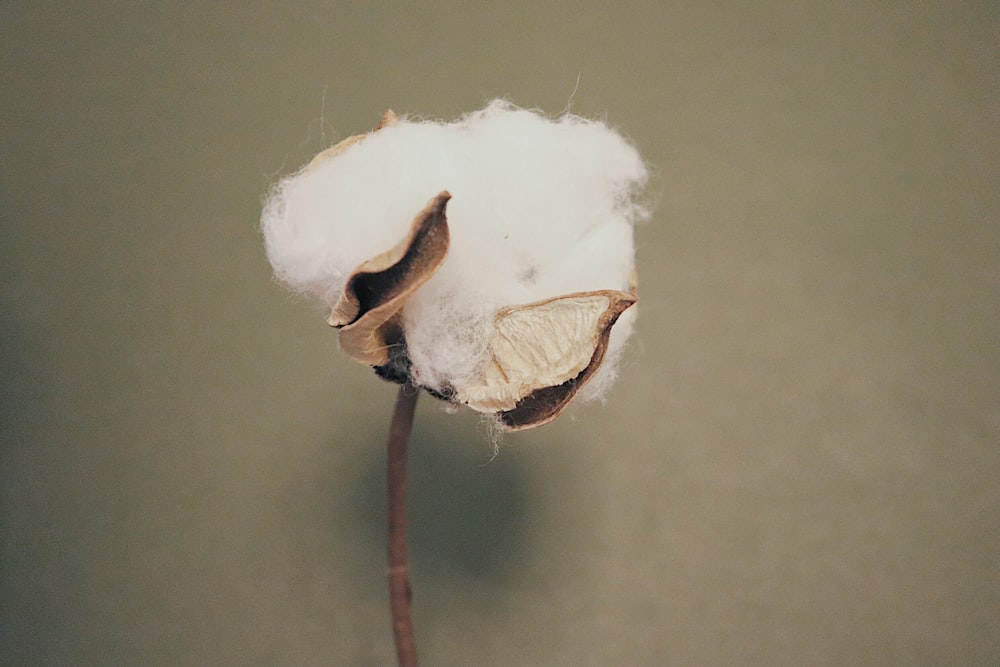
[387,383,418,667]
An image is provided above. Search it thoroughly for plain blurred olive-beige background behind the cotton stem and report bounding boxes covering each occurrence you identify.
[0,0,1000,666]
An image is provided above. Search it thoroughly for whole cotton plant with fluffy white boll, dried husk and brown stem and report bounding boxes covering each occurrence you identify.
[262,100,647,664]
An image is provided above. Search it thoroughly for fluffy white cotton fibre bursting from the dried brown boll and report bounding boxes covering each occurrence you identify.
[262,101,646,412]
